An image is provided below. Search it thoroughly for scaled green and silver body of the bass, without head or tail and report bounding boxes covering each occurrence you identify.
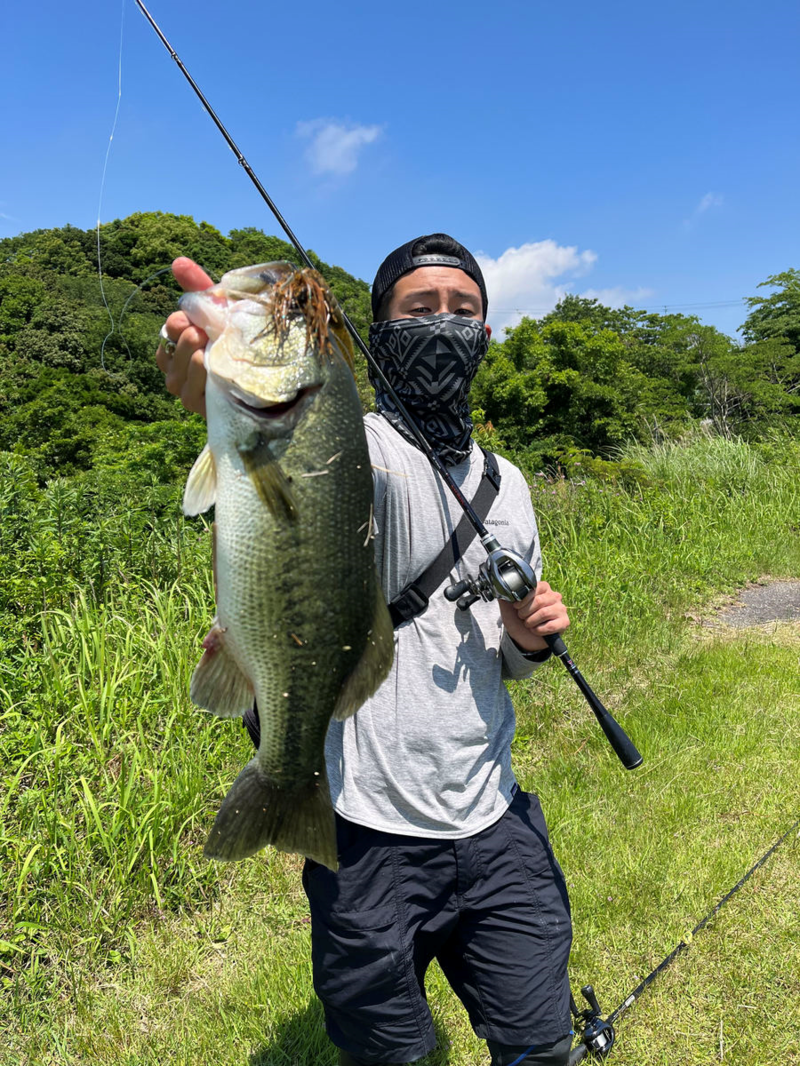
[209,357,377,789]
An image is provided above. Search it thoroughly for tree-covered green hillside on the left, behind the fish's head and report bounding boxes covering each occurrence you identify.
[0,212,370,480]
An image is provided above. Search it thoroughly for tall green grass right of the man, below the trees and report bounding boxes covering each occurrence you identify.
[531,435,800,660]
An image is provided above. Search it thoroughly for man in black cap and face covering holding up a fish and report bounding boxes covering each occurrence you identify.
[157,233,572,1066]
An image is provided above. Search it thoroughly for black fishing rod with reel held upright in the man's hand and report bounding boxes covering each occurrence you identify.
[135,0,642,770]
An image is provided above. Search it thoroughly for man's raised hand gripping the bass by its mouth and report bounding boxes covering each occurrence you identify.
[156,256,213,418]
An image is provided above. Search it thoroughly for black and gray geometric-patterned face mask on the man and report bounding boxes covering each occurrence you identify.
[369,313,489,466]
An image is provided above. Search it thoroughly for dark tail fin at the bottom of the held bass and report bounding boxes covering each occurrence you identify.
[204,758,339,870]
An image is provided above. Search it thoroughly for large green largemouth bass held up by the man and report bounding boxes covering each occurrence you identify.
[180,263,394,870]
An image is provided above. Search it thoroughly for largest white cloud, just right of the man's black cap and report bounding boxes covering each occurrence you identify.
[476,240,597,332]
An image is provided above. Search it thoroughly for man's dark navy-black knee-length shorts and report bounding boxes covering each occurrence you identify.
[303,791,572,1063]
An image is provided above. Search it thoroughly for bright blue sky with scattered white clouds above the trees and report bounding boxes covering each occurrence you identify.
[0,0,800,333]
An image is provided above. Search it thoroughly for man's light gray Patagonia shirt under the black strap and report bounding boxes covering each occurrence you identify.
[325,415,542,839]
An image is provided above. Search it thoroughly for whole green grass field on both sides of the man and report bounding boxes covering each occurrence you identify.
[0,430,800,1066]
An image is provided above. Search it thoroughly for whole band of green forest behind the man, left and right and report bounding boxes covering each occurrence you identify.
[0,212,800,482]
